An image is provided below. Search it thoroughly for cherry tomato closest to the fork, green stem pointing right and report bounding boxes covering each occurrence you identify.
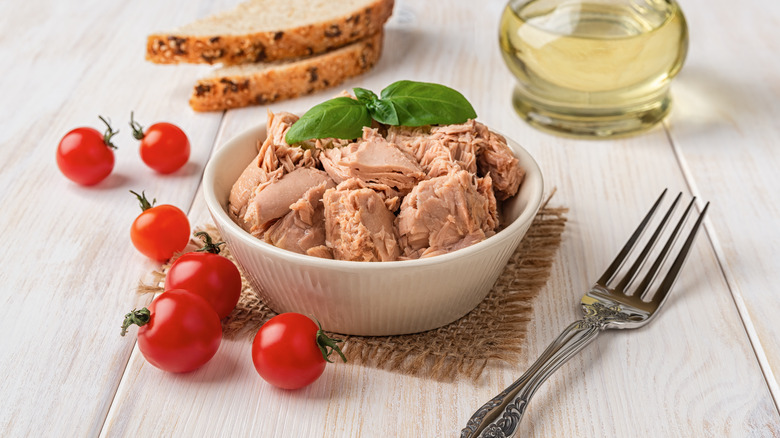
[252,313,347,389]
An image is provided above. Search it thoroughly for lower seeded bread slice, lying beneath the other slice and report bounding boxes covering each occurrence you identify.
[190,32,384,111]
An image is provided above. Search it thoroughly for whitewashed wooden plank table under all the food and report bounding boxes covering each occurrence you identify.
[0,0,780,437]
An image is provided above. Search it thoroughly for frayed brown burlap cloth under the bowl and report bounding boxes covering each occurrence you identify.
[138,198,567,381]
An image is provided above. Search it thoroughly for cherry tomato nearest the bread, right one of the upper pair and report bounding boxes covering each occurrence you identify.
[130,112,190,173]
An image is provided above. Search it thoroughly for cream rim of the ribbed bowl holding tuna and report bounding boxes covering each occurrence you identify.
[202,122,544,271]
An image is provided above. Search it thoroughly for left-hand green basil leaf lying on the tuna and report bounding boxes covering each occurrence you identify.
[284,97,371,144]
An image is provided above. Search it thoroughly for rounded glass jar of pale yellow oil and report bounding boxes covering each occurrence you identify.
[499,0,688,137]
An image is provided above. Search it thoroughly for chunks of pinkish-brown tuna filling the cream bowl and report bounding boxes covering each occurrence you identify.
[228,112,524,261]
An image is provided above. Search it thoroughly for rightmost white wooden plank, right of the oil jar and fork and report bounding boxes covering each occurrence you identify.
[668,1,780,403]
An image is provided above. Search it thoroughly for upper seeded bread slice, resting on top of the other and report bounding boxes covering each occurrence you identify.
[146,0,393,65]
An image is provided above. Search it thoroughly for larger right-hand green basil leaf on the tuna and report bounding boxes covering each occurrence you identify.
[381,81,477,126]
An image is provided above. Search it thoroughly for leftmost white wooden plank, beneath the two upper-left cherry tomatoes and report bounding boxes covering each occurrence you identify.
[0,1,227,436]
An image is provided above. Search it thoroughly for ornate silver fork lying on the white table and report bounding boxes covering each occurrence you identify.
[460,190,709,438]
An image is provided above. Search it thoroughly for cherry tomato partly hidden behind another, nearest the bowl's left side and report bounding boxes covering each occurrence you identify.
[165,231,241,319]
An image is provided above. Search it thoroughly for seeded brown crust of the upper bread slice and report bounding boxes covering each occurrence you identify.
[146,0,394,65]
